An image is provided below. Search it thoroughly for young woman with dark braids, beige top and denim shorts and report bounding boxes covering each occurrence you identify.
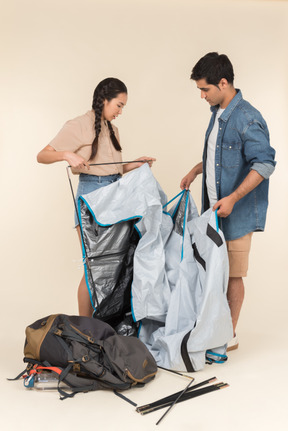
[37,78,156,316]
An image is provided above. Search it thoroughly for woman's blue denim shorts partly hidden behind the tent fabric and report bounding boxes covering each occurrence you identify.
[74,174,121,227]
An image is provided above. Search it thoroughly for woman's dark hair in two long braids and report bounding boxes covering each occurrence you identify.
[89,78,127,160]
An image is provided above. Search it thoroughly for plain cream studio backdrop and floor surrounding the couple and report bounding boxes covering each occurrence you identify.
[0,0,288,431]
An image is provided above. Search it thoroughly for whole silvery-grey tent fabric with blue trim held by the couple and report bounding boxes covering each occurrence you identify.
[78,165,233,371]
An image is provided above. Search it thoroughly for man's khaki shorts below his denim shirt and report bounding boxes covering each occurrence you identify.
[226,232,253,277]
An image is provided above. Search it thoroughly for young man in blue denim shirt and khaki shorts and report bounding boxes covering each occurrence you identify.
[180,52,276,350]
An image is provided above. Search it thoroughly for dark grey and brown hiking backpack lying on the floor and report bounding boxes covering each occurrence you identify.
[16,314,157,400]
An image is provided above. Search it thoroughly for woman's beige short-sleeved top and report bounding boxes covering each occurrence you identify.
[49,110,123,176]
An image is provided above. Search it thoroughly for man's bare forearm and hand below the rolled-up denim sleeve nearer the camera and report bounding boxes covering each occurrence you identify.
[213,169,264,217]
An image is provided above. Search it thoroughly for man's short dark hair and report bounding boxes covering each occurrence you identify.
[191,52,234,85]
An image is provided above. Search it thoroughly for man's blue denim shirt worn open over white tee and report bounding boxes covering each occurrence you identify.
[202,90,276,241]
